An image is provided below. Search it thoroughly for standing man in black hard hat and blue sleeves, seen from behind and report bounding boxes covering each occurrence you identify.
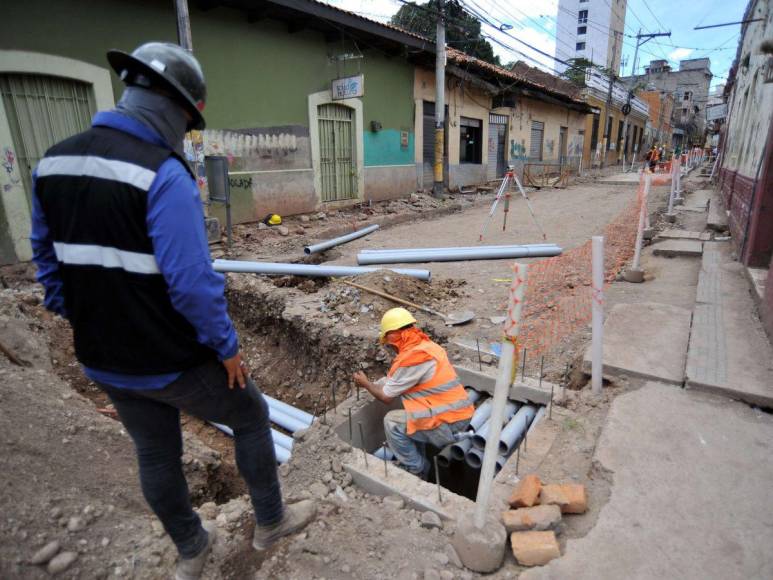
[30,42,315,580]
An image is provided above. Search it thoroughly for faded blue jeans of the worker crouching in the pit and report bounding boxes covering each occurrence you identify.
[384,409,470,476]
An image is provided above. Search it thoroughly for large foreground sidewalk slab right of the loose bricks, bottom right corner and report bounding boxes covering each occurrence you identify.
[521,382,773,580]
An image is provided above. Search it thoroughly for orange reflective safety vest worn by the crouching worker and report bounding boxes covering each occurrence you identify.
[387,340,475,435]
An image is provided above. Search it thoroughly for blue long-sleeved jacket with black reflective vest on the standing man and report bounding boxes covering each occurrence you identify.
[30,112,239,389]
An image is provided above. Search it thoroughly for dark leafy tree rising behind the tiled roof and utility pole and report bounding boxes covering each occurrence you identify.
[391,0,500,66]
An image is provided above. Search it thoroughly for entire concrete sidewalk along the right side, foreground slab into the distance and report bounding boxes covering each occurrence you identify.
[544,174,773,580]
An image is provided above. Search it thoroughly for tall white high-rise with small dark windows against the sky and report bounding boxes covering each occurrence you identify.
[556,0,627,74]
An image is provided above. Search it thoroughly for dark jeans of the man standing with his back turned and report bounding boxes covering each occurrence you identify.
[99,360,283,558]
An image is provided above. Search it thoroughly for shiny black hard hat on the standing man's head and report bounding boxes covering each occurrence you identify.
[107,42,207,130]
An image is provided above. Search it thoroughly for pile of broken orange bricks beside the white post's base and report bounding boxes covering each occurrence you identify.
[502,475,588,566]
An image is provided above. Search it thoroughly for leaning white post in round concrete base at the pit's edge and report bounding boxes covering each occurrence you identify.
[474,263,528,530]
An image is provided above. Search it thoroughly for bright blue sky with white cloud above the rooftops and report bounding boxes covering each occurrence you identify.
[323,0,746,90]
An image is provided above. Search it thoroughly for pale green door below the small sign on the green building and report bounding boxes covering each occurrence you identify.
[318,104,357,202]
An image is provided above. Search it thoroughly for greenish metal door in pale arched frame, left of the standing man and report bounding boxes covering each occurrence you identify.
[0,74,96,204]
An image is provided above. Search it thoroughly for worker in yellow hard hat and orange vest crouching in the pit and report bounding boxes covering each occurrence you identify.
[354,308,475,479]
